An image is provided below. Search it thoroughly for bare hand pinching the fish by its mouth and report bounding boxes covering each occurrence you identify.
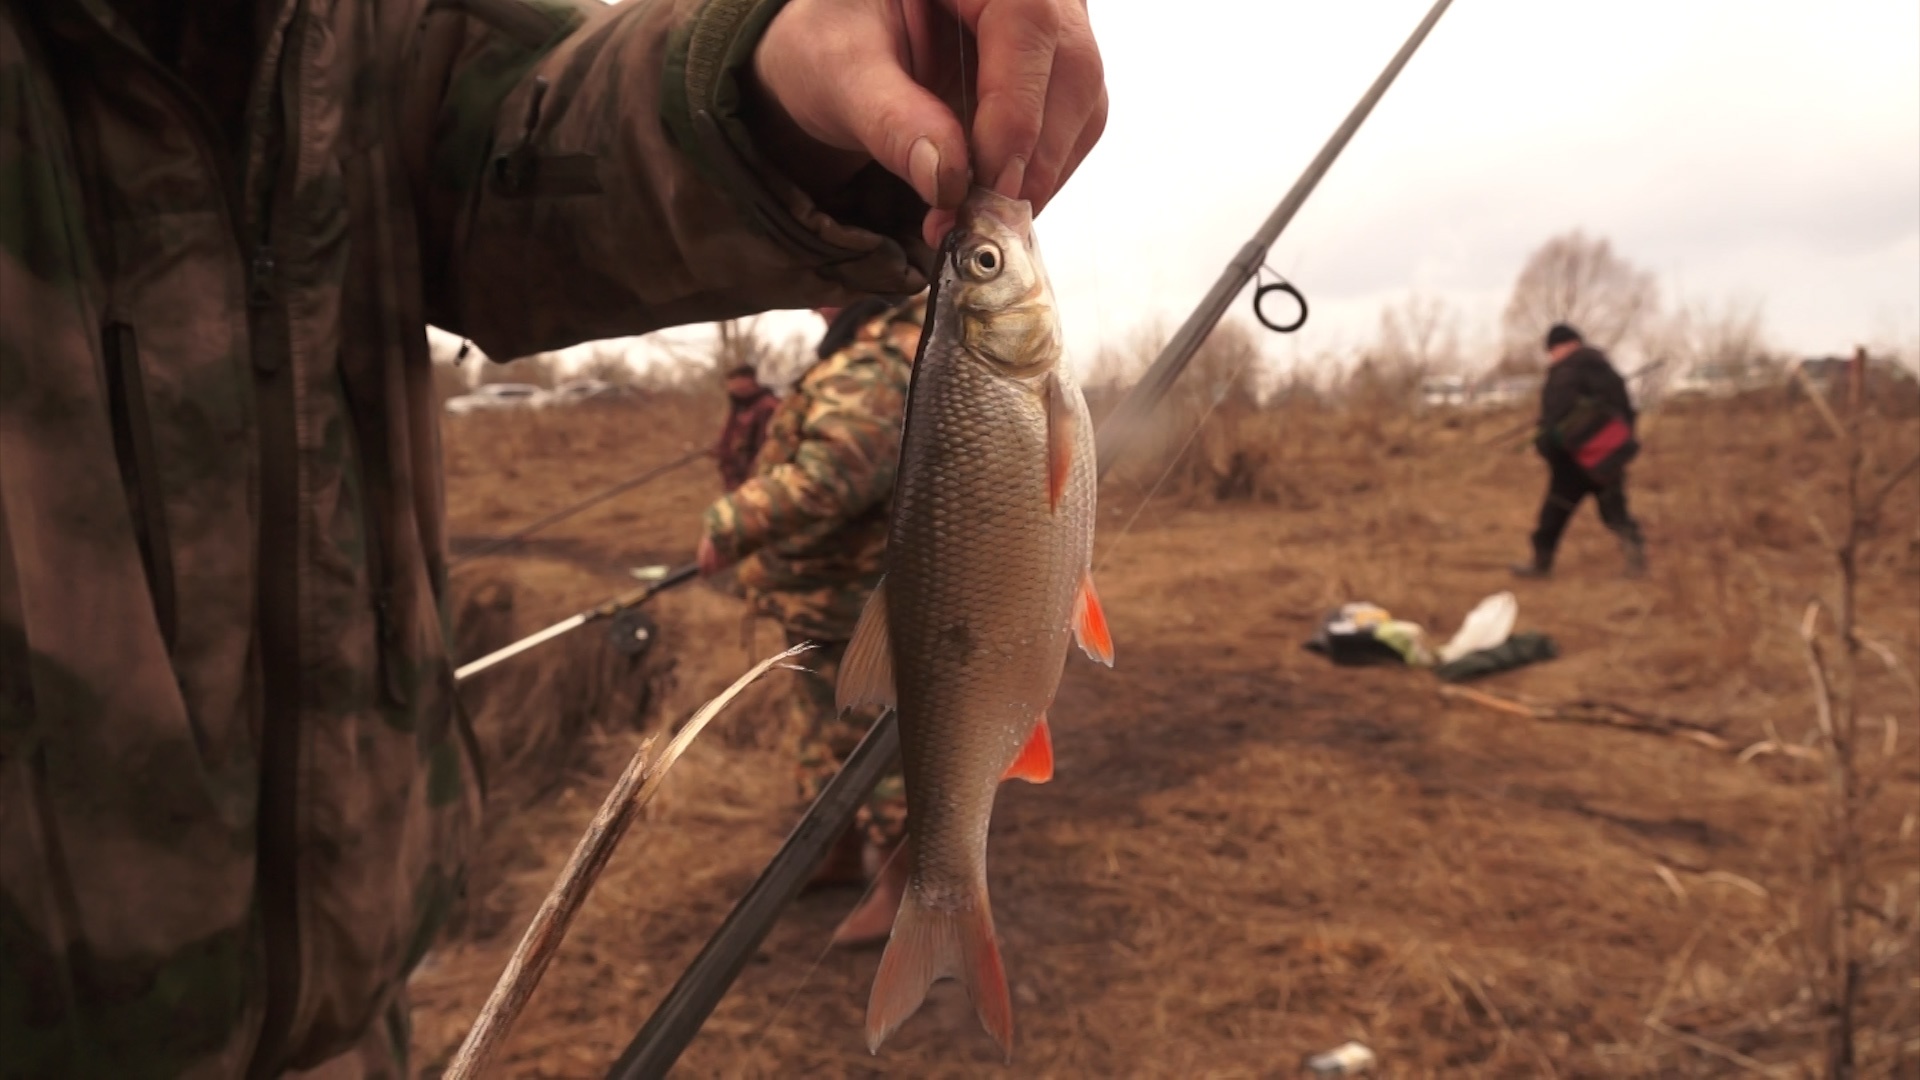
[753,0,1108,244]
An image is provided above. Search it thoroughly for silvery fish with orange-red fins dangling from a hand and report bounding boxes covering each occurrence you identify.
[837,188,1114,1059]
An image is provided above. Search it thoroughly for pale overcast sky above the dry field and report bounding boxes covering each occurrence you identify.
[464,0,1920,378]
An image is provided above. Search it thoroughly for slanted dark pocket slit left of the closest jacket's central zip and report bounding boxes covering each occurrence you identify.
[102,317,179,653]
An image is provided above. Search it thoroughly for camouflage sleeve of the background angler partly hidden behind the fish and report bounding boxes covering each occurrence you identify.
[705,363,900,559]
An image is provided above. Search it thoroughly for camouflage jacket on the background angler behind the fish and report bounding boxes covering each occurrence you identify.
[705,296,925,642]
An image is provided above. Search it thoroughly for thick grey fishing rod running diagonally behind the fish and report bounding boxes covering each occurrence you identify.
[607,0,1452,1080]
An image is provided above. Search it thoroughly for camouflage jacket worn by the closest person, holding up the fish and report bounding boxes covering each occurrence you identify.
[0,0,929,1078]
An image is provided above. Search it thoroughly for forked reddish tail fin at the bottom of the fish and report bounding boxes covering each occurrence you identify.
[866,880,1014,1063]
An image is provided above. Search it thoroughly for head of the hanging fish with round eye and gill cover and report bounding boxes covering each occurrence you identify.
[941,188,1062,380]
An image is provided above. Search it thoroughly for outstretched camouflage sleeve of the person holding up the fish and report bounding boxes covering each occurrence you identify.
[394,0,931,357]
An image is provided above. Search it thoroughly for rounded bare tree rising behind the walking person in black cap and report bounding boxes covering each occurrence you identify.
[1501,229,1659,356]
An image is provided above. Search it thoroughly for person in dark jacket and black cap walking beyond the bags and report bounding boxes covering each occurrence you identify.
[1513,323,1647,578]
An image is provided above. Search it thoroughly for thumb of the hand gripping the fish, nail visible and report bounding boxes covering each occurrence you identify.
[839,56,968,208]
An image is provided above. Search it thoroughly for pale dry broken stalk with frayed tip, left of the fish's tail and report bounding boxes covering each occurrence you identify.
[444,644,814,1080]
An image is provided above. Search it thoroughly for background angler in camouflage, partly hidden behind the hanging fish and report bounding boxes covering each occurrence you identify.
[701,294,927,945]
